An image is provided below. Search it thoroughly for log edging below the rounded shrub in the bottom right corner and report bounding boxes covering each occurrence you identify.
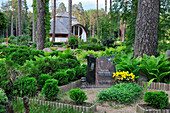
[136,104,170,113]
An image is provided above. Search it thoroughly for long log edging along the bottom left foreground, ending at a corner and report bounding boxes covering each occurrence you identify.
[16,97,96,113]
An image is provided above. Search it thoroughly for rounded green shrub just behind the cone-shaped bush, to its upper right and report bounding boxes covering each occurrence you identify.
[52,72,68,86]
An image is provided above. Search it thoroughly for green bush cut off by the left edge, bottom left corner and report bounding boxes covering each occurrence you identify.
[0,88,8,113]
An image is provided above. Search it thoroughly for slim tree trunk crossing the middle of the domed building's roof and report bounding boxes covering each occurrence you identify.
[68,0,72,38]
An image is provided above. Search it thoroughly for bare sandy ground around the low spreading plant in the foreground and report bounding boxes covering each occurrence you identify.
[83,88,170,113]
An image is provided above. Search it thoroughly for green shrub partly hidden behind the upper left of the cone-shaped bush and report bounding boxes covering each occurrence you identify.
[37,74,51,89]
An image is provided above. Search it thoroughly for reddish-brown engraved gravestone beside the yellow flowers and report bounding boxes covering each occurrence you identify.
[95,57,116,86]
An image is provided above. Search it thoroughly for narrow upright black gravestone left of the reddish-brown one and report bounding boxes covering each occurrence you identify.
[86,55,96,84]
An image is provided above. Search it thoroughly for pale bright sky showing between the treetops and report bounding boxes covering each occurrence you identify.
[0,0,110,12]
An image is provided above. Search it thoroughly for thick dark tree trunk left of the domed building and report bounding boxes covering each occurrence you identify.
[37,0,46,50]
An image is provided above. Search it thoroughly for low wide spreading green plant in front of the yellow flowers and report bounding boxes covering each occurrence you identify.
[97,83,143,104]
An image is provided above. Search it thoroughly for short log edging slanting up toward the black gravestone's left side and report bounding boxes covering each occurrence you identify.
[59,79,81,94]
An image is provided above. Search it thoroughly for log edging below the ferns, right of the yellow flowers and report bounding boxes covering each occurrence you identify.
[137,81,170,91]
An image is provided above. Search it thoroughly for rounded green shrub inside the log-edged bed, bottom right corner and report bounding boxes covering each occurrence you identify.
[144,91,169,109]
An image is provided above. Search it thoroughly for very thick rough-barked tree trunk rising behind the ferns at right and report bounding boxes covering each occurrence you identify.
[134,0,160,57]
